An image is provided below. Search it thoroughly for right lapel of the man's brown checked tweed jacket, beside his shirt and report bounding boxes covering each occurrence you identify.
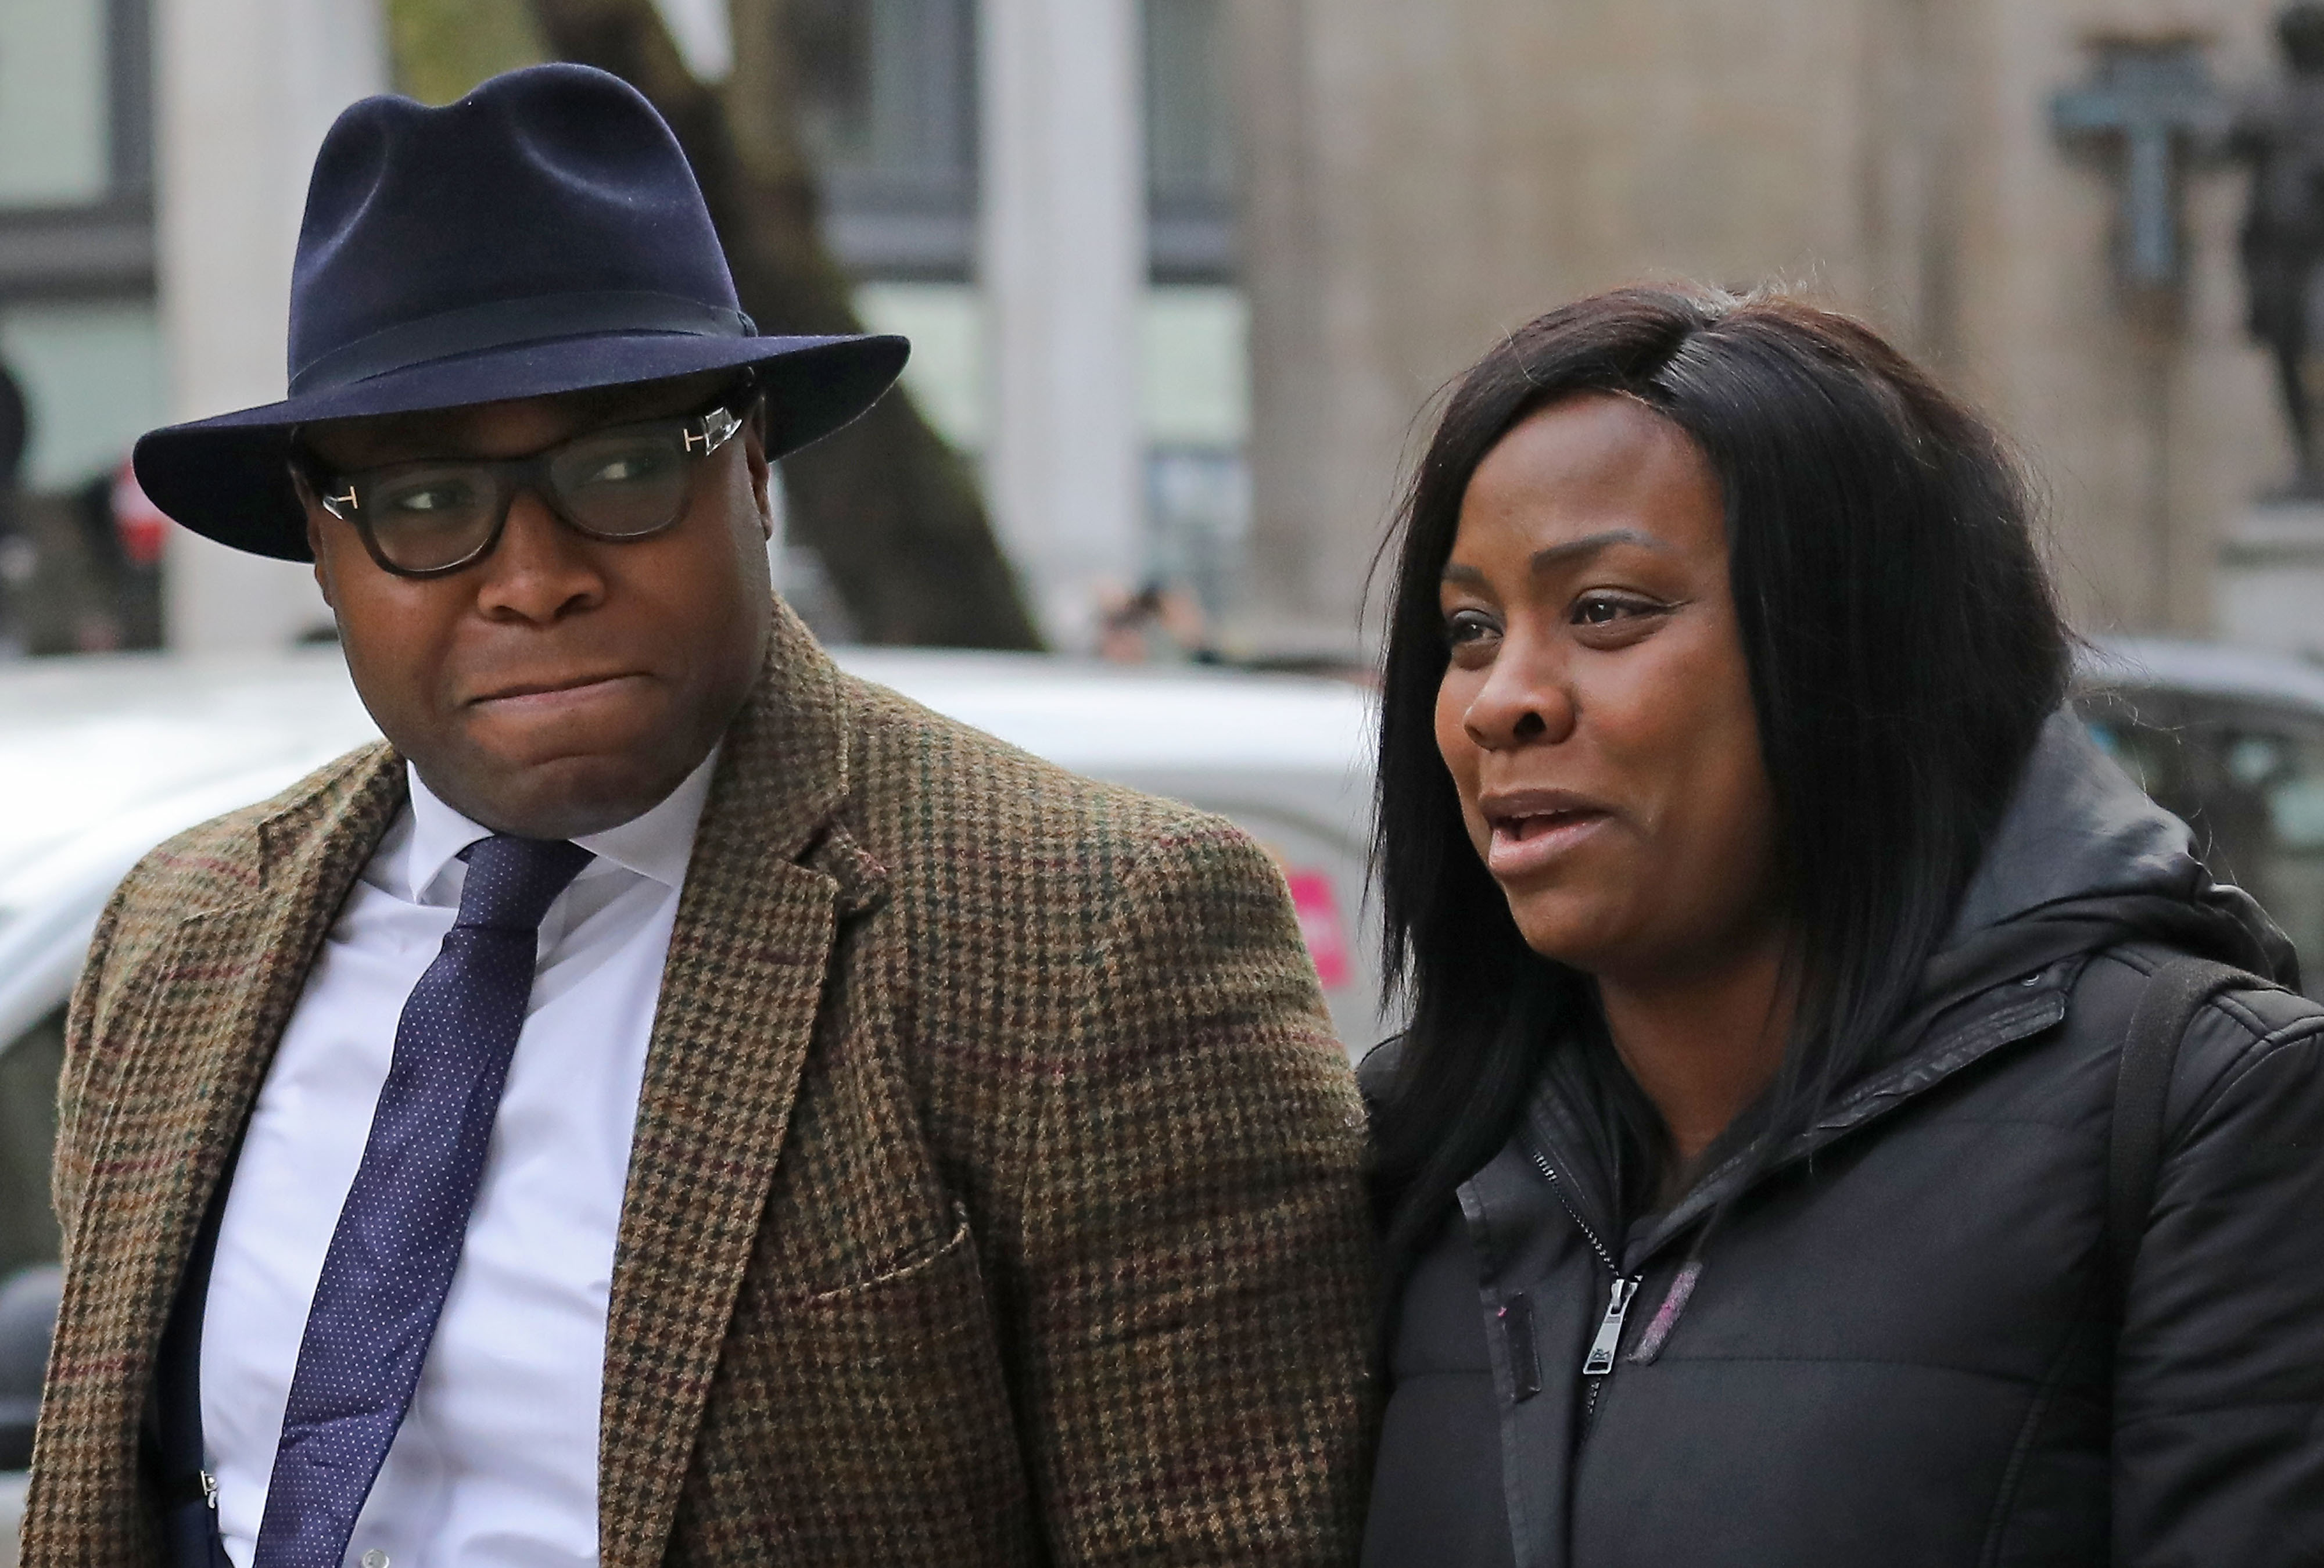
[597,607,862,1568]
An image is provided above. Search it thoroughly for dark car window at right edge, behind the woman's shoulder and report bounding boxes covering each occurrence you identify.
[2082,692,2324,992]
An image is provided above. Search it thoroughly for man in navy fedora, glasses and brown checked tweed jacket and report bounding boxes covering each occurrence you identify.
[23,65,1371,1568]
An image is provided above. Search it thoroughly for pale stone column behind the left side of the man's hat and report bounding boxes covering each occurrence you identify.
[153,0,388,651]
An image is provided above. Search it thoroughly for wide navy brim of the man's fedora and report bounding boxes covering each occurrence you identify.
[132,332,911,560]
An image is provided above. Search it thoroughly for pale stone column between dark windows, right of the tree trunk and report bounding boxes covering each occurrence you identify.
[978,0,1146,648]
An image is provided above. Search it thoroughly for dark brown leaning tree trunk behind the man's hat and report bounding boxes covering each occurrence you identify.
[507,0,1041,648]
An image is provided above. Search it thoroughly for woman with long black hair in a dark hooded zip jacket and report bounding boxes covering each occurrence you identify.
[1362,290,2324,1568]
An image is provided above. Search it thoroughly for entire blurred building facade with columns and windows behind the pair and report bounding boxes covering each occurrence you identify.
[0,0,2289,655]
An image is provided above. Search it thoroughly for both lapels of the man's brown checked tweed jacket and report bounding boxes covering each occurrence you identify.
[60,604,885,1568]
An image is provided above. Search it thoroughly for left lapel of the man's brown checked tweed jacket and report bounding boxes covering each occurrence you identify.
[37,746,402,1561]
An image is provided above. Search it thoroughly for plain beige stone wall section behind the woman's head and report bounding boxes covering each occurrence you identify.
[1232,0,2291,644]
